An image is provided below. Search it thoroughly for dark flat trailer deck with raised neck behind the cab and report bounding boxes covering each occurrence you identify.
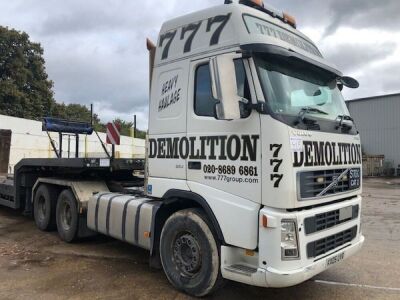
[0,158,145,213]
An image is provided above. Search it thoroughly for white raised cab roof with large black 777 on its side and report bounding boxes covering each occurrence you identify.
[155,0,340,73]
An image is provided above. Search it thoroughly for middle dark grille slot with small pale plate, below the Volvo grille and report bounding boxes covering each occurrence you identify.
[304,204,359,234]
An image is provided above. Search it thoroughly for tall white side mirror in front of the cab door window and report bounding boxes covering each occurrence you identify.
[210,54,242,120]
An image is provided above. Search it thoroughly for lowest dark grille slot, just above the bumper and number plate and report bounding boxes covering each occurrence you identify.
[307,226,357,258]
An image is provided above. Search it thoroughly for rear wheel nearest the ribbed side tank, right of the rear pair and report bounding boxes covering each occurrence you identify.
[56,190,79,243]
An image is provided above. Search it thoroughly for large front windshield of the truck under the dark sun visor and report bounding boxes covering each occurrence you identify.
[255,55,349,121]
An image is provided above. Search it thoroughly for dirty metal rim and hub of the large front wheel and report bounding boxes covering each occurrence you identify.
[172,232,201,277]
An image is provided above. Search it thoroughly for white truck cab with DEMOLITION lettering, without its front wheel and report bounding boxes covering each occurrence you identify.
[145,1,364,295]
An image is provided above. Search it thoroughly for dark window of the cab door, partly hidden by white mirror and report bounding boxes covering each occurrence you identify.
[194,59,251,118]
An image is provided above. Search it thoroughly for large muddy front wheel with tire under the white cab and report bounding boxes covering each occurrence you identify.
[160,209,223,297]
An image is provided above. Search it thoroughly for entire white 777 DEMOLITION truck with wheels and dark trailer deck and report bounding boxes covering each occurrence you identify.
[0,0,364,296]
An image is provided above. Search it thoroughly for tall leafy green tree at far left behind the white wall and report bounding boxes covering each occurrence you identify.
[0,26,55,120]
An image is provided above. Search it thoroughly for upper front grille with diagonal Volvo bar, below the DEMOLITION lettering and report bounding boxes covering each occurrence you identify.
[299,169,359,199]
